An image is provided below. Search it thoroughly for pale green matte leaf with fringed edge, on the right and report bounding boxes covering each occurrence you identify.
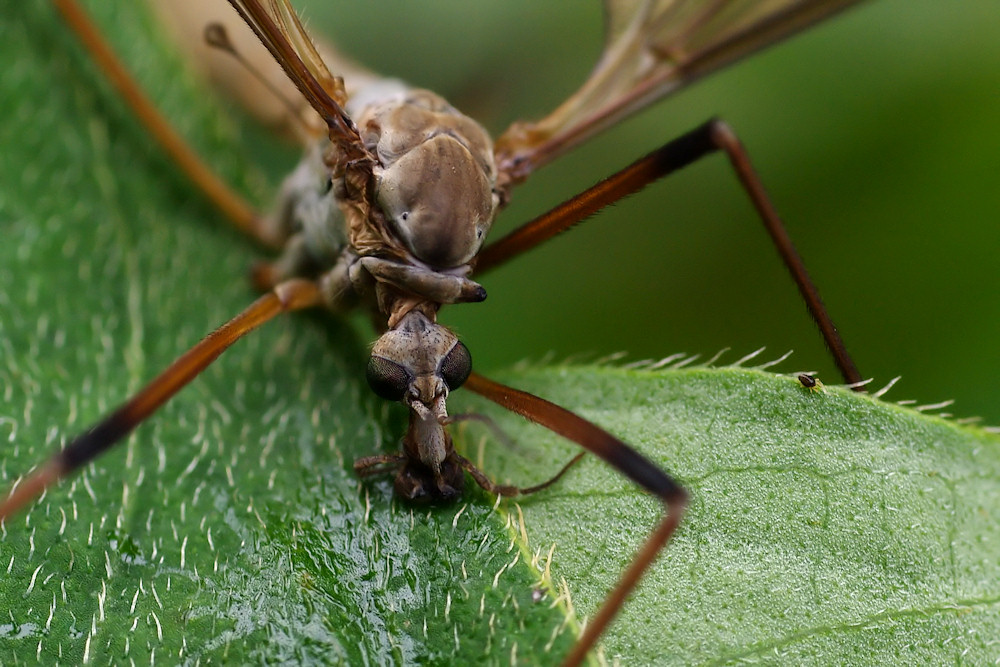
[458,366,1000,664]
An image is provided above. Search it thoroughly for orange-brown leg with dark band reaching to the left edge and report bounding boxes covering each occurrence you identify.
[0,280,321,521]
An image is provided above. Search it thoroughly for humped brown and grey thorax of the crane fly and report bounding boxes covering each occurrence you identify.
[275,80,499,327]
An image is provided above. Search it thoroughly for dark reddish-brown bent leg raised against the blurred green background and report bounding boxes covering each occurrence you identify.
[476,119,862,389]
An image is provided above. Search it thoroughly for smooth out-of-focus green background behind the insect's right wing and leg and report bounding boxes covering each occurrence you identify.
[284,0,1000,423]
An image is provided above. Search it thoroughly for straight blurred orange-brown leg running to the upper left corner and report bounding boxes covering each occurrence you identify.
[52,0,284,249]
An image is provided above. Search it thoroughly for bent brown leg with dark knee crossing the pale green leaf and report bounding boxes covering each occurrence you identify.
[464,373,687,665]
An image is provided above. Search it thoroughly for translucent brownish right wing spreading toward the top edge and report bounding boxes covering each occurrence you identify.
[496,0,859,186]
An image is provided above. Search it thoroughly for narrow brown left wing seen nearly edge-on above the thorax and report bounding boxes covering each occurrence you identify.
[229,0,370,161]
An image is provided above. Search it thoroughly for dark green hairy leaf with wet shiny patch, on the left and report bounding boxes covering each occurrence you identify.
[0,3,572,664]
